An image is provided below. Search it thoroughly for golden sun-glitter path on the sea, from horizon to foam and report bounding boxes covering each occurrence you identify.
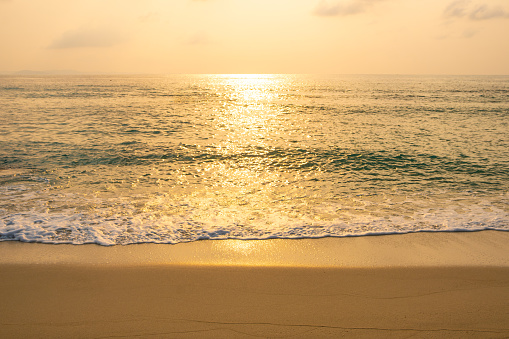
[139,74,304,239]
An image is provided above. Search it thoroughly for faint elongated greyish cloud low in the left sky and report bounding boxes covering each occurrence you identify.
[49,28,127,49]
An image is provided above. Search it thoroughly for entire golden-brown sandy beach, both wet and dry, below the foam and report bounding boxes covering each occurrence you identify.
[0,231,509,338]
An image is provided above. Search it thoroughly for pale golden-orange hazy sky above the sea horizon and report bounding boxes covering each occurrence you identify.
[0,0,509,75]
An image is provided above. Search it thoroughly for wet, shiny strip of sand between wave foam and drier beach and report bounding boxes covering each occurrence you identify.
[0,230,509,267]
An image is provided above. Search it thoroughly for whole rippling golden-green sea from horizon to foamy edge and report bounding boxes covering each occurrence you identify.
[0,75,509,245]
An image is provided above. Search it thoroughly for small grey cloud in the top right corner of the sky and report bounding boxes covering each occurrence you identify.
[444,0,509,21]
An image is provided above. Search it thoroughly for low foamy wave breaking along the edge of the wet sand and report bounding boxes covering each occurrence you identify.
[0,202,509,246]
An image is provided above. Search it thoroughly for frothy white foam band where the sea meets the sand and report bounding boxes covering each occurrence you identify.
[0,196,509,246]
